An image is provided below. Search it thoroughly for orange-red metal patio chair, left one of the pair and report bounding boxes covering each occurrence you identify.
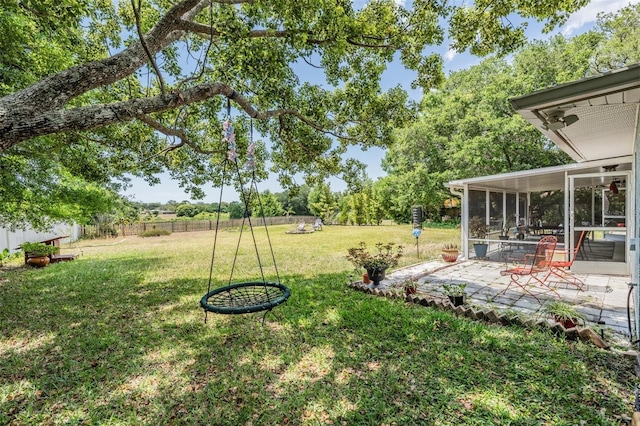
[496,235,560,302]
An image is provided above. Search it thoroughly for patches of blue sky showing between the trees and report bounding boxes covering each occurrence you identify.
[122,0,640,203]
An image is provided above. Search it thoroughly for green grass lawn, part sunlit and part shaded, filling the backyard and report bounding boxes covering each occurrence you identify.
[0,226,636,425]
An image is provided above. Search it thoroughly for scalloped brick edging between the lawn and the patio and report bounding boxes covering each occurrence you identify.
[348,281,610,349]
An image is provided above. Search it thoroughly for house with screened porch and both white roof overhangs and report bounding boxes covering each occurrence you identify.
[448,64,640,281]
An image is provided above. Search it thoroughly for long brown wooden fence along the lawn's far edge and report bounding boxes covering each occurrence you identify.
[80,216,316,238]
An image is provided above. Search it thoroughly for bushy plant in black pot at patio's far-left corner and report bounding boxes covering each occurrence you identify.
[347,241,403,285]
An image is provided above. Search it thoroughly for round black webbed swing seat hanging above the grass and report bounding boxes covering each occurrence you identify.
[200,281,291,314]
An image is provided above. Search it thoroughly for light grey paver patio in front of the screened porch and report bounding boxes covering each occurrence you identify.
[379,260,634,342]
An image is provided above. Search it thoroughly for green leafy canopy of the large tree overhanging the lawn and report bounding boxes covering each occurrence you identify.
[0,0,600,230]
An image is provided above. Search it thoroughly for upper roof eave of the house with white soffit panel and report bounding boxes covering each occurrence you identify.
[509,64,640,162]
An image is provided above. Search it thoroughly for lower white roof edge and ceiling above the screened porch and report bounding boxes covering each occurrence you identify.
[449,156,633,192]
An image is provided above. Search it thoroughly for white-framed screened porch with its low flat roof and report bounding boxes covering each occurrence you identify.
[449,156,634,274]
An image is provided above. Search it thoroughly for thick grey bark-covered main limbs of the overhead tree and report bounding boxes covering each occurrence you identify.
[0,0,380,152]
